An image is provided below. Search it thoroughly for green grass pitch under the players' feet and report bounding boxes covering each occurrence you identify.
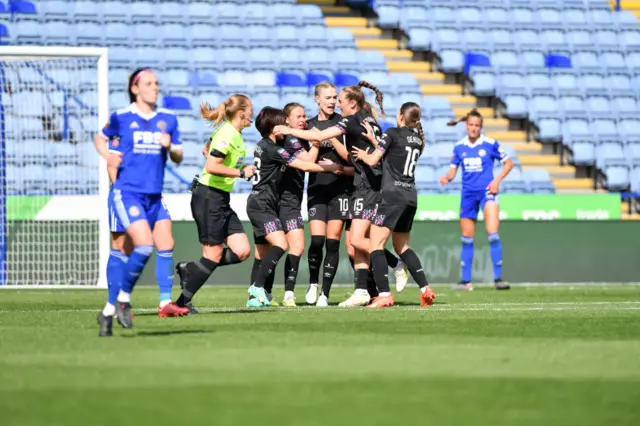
[0,285,640,426]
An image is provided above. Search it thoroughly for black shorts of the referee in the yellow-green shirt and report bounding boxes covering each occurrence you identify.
[191,184,244,245]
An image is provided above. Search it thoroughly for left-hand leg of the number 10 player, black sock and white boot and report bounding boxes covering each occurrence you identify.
[305,202,328,305]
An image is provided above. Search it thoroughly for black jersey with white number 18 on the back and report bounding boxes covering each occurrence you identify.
[378,127,422,205]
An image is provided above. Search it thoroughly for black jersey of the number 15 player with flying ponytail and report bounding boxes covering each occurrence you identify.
[338,110,382,191]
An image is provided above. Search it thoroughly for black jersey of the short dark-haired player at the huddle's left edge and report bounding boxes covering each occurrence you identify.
[251,138,294,200]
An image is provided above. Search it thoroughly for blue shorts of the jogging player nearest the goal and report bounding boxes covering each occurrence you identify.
[109,189,171,232]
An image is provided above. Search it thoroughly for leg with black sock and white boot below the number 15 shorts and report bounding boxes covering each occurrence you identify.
[340,219,371,307]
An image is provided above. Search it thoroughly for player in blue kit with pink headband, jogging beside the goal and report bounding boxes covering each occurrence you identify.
[98,68,189,336]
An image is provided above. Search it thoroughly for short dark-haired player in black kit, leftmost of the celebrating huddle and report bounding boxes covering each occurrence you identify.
[247,107,340,307]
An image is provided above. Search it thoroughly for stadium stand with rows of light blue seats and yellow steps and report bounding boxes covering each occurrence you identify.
[0,0,640,216]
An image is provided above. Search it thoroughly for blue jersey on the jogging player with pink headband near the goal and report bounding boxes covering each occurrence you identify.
[101,104,181,194]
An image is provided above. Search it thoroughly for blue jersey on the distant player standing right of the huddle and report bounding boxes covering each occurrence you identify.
[451,135,507,191]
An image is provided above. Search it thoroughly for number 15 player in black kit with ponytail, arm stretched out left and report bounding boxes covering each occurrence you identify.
[274,81,399,307]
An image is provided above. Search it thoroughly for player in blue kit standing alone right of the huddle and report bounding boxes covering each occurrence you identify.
[440,109,513,290]
